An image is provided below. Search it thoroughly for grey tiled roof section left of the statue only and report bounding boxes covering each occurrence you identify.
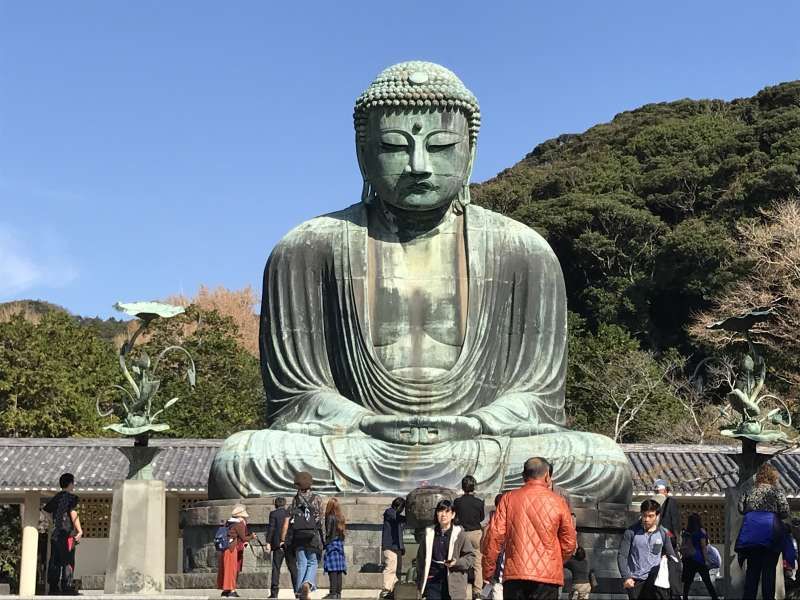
[0,438,222,493]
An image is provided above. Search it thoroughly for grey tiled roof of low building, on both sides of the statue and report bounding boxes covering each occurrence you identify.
[0,438,800,497]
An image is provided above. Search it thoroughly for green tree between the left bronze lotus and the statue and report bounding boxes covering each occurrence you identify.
[133,305,265,438]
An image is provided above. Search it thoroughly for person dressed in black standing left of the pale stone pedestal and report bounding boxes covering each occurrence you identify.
[44,473,83,596]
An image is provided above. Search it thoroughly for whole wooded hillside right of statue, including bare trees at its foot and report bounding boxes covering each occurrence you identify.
[472,81,800,442]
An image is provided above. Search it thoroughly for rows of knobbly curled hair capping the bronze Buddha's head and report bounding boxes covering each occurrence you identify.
[353,60,481,144]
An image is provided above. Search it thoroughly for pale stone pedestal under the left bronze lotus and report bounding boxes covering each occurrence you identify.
[104,479,165,594]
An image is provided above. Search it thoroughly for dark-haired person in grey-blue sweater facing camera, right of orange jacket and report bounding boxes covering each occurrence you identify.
[617,500,678,600]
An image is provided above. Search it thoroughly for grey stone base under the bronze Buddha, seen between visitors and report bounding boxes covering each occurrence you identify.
[181,488,638,593]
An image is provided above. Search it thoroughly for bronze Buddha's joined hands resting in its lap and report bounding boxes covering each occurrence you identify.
[361,415,481,445]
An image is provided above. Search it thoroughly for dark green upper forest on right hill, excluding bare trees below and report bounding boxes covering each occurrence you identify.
[473,81,800,352]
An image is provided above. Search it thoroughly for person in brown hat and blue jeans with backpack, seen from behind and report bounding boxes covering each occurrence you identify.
[281,471,322,600]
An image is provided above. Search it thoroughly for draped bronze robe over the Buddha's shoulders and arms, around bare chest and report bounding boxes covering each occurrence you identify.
[261,204,567,437]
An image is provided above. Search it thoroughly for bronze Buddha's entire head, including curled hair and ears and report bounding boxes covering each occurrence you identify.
[354,61,480,211]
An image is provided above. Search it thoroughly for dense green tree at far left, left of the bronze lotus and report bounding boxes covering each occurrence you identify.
[0,311,120,437]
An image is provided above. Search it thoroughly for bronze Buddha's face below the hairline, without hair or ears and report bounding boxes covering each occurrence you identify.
[361,110,470,211]
